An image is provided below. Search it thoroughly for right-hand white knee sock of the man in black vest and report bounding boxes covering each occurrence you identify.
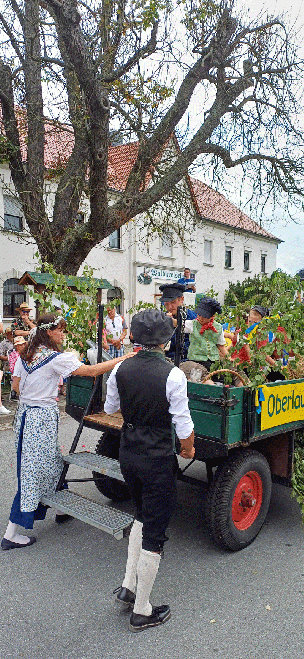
[133,549,160,616]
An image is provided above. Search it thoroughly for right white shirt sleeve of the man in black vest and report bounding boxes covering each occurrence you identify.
[166,366,194,439]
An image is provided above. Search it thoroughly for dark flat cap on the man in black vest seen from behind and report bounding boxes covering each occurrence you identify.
[131,309,174,346]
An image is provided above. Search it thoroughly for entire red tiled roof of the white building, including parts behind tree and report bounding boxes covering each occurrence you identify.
[0,109,281,242]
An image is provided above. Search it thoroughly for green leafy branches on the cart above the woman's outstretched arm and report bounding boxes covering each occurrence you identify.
[27,262,111,355]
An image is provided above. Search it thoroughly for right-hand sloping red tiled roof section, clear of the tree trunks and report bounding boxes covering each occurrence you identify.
[189,176,281,242]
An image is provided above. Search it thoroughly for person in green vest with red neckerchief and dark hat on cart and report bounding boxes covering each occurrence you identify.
[185,297,228,371]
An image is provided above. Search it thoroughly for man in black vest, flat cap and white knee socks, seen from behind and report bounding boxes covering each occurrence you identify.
[104,309,194,632]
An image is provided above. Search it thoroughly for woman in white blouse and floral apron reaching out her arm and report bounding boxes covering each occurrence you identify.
[1,313,133,550]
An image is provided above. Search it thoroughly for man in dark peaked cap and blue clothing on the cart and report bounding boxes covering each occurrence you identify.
[159,282,196,361]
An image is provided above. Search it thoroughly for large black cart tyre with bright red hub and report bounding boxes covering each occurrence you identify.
[207,450,271,551]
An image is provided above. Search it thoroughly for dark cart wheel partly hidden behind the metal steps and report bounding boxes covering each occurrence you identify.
[92,430,131,501]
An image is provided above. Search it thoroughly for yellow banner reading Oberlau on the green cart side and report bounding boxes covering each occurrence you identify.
[261,381,304,430]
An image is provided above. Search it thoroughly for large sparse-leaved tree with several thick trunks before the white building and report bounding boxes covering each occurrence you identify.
[0,0,304,274]
